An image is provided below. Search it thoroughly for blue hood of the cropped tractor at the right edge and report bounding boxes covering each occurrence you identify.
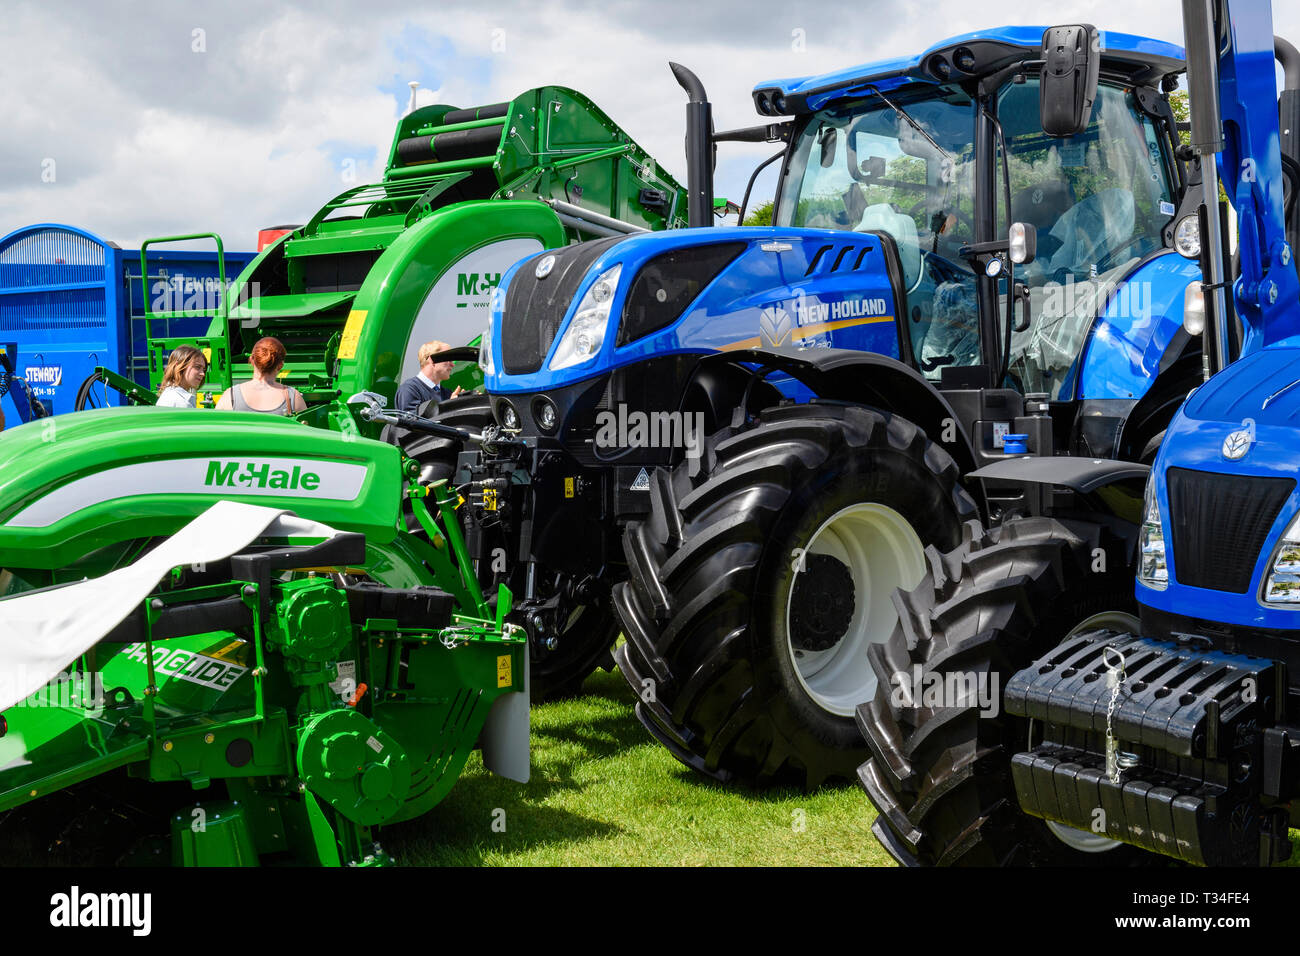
[1138,347,1300,630]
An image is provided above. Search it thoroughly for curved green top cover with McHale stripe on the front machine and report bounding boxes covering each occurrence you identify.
[0,407,402,568]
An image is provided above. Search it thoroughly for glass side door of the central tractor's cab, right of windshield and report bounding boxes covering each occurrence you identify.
[997,79,1174,399]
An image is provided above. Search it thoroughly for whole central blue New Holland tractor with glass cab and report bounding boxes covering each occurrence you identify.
[470,27,1203,787]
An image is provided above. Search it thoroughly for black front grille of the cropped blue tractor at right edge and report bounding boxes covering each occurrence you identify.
[1165,468,1296,594]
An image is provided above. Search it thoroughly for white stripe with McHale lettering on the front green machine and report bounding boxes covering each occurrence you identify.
[7,458,368,528]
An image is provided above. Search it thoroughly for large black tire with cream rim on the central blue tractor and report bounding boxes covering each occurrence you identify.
[615,403,976,790]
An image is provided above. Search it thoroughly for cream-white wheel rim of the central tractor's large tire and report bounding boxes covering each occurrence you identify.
[785,503,926,717]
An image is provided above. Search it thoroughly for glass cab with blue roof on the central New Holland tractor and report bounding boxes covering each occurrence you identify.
[755,27,1186,399]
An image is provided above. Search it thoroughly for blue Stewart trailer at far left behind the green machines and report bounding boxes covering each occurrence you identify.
[0,222,256,423]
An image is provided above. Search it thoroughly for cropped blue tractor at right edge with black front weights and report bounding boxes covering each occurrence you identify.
[858,0,1300,865]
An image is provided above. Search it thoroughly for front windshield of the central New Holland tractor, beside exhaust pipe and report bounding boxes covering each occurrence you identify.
[776,87,980,378]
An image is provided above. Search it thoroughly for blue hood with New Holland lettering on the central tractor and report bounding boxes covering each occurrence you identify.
[484,228,902,394]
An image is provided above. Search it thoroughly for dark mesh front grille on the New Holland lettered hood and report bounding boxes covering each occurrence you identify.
[501,235,627,375]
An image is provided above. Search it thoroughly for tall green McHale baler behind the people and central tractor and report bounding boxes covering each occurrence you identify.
[142,86,686,405]
